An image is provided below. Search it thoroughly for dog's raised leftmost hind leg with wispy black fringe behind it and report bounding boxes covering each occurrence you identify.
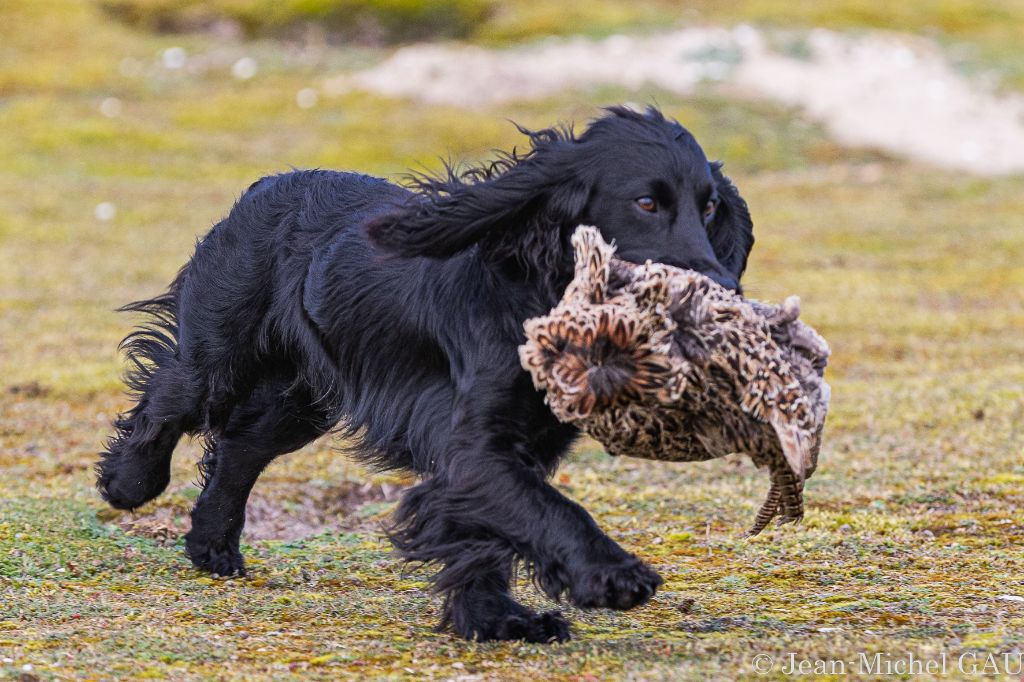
[96,269,194,509]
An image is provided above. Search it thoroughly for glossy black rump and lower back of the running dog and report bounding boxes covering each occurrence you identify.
[178,171,404,411]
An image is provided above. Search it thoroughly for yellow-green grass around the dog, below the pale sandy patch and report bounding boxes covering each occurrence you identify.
[0,0,1024,680]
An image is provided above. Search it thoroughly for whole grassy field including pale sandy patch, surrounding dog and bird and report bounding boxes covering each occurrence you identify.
[0,0,1024,679]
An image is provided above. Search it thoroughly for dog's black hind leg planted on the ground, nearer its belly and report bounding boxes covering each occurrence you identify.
[185,383,332,576]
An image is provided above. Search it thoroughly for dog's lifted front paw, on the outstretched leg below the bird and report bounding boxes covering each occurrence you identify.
[569,555,662,610]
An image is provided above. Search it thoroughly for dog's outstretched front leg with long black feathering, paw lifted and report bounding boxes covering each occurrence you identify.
[392,382,662,620]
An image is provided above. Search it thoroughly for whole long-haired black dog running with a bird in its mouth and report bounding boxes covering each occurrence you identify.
[97,108,754,642]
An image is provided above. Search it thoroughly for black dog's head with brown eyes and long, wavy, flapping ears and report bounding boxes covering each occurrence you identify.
[368,106,754,289]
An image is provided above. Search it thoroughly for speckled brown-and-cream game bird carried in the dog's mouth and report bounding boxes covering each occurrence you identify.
[519,226,829,535]
